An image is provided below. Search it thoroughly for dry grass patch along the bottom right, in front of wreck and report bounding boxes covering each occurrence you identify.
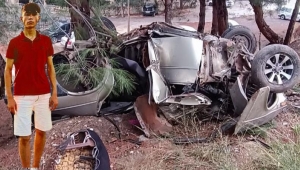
[113,113,300,170]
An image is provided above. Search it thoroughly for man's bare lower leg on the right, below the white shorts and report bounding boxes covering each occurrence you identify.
[32,129,46,168]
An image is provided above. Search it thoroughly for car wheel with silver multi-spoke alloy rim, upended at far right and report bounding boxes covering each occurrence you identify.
[251,44,300,93]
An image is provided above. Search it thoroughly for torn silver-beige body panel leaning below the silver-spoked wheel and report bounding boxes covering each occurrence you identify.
[234,86,287,134]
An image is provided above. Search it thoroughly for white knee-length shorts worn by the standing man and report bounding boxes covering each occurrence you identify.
[14,93,52,136]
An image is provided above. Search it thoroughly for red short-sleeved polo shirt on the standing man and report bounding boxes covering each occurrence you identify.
[6,31,54,95]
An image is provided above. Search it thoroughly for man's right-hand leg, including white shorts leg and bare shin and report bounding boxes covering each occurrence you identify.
[33,94,52,168]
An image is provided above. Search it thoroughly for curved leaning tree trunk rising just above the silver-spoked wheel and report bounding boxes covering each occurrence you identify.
[250,0,283,44]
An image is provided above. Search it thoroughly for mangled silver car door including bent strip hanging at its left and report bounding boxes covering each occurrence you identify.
[147,36,203,103]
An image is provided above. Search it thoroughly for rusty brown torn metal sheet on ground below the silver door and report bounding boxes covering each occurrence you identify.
[134,95,172,137]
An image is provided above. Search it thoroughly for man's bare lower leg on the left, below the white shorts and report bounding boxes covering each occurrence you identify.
[19,136,30,168]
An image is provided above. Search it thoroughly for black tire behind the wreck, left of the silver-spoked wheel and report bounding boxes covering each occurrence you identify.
[222,25,257,53]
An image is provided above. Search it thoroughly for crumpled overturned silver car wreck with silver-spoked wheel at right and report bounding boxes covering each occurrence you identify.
[113,23,300,136]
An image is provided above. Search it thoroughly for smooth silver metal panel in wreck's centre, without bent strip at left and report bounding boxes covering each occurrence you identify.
[149,37,203,85]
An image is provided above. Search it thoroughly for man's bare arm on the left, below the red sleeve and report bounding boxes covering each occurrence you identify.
[4,58,14,99]
